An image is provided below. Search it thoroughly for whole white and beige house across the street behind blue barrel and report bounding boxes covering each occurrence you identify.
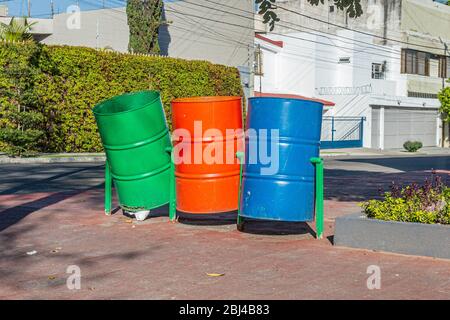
[255,0,450,149]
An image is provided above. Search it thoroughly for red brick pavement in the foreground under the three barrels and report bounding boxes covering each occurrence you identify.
[0,185,450,299]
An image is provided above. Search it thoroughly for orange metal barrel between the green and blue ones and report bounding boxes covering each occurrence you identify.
[172,97,244,214]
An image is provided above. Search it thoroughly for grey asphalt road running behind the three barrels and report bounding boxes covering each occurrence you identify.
[0,156,450,196]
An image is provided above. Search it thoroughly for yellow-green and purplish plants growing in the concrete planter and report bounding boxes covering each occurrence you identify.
[361,176,450,224]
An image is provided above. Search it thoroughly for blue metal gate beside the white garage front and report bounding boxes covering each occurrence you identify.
[321,116,366,149]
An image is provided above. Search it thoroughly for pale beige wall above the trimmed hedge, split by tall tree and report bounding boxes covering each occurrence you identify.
[42,0,254,68]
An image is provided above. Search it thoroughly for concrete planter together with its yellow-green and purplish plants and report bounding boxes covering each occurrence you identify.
[334,176,450,259]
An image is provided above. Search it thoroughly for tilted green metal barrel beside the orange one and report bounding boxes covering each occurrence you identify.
[93,91,171,210]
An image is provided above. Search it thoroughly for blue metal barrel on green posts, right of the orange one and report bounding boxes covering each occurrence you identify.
[241,97,323,221]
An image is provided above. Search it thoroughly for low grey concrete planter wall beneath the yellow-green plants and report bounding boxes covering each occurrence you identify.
[334,213,450,259]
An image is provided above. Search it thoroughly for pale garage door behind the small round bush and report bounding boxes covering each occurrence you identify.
[372,107,439,149]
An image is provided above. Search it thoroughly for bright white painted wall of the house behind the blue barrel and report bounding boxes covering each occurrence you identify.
[255,30,444,147]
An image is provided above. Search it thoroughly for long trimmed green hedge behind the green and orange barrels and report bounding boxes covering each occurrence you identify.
[0,42,242,152]
